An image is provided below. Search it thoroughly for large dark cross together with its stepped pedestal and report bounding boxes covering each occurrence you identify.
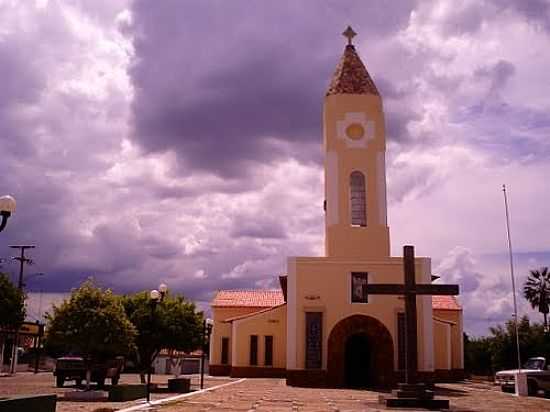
[367,246,464,409]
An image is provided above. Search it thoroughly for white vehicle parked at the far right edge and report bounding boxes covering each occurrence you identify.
[495,357,550,395]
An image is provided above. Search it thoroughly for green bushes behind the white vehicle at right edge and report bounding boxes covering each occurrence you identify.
[464,316,550,375]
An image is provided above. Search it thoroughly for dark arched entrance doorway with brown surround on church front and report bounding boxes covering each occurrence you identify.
[327,315,394,387]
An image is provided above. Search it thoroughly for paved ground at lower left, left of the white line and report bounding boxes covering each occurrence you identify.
[0,372,232,412]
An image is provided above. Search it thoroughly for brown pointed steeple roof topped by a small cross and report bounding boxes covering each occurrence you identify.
[326,26,379,96]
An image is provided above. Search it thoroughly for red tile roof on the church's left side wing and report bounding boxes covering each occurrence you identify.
[211,289,285,308]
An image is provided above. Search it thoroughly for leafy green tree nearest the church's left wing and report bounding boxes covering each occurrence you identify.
[122,292,203,382]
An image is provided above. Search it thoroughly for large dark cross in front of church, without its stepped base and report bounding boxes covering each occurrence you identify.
[366,246,458,384]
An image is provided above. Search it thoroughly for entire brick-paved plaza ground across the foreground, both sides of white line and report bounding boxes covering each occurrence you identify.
[0,373,550,412]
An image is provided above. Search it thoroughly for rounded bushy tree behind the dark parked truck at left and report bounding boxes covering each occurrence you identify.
[46,280,136,388]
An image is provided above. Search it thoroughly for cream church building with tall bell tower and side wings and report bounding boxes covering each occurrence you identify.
[210,28,464,387]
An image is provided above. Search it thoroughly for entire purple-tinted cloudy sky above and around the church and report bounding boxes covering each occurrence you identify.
[0,0,550,333]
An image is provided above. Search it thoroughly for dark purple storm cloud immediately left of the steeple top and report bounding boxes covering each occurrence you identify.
[129,1,410,176]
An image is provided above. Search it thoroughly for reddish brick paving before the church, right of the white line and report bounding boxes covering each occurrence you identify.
[157,379,550,412]
